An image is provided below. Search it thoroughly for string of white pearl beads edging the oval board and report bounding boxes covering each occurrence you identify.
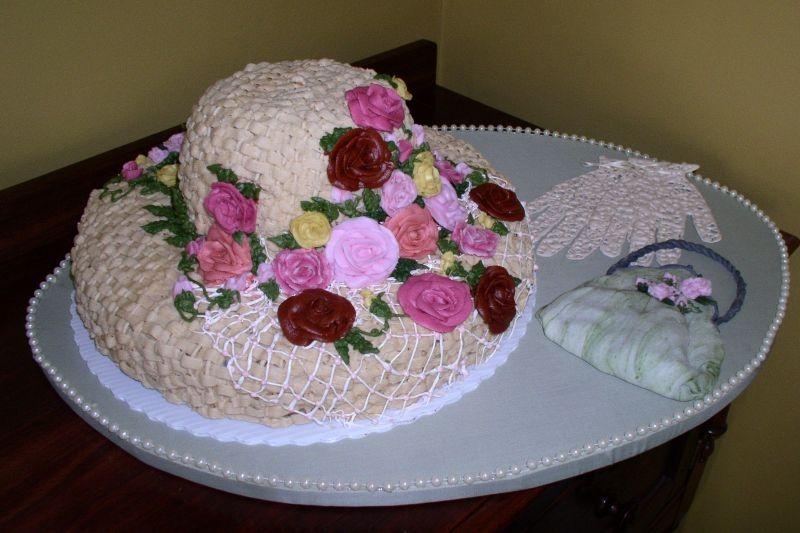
[25,129,789,493]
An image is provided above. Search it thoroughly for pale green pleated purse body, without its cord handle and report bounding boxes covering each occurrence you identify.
[536,267,725,401]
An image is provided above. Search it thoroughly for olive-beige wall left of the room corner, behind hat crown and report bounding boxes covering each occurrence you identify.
[0,0,440,188]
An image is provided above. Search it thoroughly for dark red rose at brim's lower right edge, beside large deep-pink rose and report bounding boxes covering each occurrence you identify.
[475,265,517,334]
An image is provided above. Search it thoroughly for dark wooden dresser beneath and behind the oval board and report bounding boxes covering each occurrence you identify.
[0,41,798,531]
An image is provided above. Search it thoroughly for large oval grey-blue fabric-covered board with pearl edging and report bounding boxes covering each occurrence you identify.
[26,128,789,506]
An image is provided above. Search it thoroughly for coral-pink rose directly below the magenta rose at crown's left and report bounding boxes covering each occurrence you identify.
[197,224,253,286]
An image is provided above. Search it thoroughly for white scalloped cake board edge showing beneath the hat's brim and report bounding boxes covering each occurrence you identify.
[70,291,536,446]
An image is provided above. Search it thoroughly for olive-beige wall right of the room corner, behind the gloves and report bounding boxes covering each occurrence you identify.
[439,0,800,532]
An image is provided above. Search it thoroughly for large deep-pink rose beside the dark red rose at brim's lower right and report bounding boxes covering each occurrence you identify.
[397,272,473,333]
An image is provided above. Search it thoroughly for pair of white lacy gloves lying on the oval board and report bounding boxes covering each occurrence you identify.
[527,157,722,265]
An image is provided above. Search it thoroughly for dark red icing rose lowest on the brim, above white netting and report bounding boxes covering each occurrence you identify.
[278,289,356,346]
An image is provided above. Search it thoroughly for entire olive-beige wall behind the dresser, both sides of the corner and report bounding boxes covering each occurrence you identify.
[0,0,800,531]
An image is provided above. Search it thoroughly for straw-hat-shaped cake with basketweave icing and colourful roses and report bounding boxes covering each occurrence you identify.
[72,60,535,426]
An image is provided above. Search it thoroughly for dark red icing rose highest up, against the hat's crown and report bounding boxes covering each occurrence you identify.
[328,128,394,191]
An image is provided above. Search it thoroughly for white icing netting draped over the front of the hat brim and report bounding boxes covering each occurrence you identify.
[197,205,534,423]
